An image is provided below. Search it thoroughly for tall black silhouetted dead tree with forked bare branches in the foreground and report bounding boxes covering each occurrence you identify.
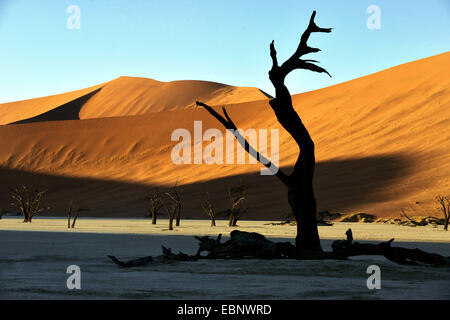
[197,11,332,251]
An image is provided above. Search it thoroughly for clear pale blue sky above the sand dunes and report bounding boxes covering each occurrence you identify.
[0,0,450,102]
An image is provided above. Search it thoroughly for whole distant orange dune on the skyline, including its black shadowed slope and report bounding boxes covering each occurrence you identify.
[0,77,266,124]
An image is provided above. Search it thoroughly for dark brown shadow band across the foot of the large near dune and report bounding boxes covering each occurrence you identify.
[0,155,413,219]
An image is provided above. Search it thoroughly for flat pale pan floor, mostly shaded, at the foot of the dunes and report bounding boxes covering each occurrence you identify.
[0,218,450,300]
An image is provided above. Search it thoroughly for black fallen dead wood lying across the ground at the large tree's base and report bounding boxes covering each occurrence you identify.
[108,229,450,268]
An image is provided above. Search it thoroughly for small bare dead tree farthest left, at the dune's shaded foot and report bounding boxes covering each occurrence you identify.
[10,185,46,223]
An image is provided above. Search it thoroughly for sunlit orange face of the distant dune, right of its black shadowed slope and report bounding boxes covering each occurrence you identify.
[80,77,266,119]
